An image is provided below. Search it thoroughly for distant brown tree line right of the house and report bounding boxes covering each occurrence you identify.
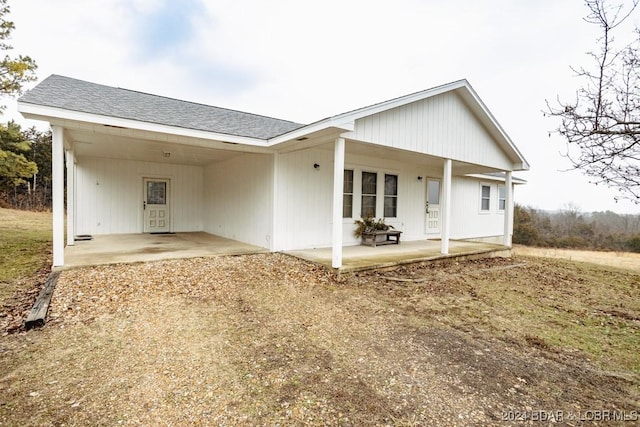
[513,204,640,252]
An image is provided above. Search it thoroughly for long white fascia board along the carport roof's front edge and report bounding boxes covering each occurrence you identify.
[18,102,267,147]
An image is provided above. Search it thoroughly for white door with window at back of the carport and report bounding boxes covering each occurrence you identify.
[143,178,171,233]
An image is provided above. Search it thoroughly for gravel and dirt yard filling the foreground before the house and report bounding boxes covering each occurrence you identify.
[0,254,640,426]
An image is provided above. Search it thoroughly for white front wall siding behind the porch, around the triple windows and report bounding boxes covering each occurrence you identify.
[276,149,442,250]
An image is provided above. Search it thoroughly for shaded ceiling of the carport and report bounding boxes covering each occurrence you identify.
[65,129,248,166]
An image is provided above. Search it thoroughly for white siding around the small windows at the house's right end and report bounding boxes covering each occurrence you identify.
[451,177,504,243]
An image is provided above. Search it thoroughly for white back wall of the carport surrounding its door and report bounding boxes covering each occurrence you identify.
[76,157,203,234]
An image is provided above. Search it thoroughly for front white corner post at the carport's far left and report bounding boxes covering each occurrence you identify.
[51,126,64,267]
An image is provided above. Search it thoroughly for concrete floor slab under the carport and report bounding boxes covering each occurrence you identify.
[64,232,268,268]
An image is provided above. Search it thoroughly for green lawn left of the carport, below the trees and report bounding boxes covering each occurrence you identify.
[0,209,51,305]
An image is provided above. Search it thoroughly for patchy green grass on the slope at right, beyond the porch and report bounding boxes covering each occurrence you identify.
[464,260,640,375]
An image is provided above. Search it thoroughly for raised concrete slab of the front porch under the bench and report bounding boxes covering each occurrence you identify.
[285,240,511,272]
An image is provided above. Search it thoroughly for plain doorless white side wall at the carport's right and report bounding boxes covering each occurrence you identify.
[204,154,273,248]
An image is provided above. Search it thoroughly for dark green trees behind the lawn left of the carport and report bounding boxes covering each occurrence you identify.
[0,121,51,210]
